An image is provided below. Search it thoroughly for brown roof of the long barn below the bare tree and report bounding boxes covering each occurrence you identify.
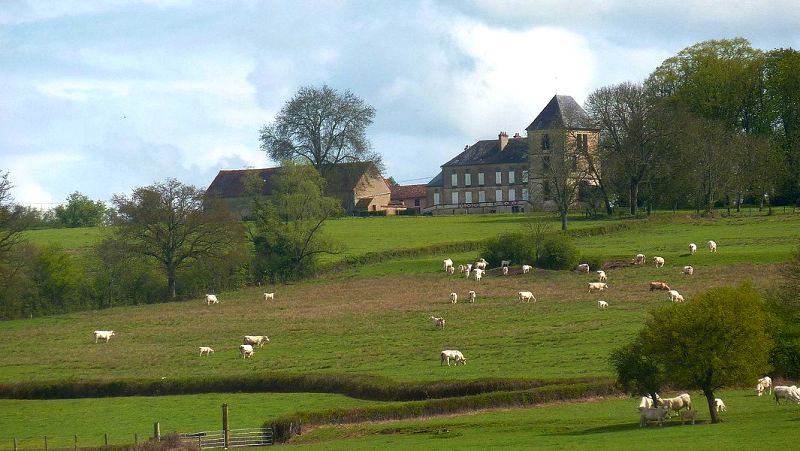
[206,162,388,198]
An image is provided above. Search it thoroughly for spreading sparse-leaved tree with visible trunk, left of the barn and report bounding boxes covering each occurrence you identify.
[112,179,246,299]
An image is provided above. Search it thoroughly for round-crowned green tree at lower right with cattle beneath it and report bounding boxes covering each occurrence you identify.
[618,284,772,423]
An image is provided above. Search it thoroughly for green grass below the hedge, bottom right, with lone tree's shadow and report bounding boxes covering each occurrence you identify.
[290,390,800,450]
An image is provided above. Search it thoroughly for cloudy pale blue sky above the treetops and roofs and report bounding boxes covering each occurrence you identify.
[0,0,800,209]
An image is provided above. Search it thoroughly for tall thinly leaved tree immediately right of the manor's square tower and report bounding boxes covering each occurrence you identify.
[586,82,664,215]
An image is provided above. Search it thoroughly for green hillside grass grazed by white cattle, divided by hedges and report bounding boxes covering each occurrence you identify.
[6,214,800,449]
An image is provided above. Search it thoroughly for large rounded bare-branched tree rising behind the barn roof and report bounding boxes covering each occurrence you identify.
[260,85,380,177]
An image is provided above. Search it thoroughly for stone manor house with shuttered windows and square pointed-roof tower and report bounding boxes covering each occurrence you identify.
[425,95,599,214]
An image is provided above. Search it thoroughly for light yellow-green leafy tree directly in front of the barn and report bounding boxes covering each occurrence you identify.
[250,163,342,282]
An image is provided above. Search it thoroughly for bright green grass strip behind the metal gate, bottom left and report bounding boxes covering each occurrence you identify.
[0,393,372,449]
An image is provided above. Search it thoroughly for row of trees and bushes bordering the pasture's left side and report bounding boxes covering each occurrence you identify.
[0,167,341,319]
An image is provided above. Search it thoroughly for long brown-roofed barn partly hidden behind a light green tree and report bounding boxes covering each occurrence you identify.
[206,162,391,217]
